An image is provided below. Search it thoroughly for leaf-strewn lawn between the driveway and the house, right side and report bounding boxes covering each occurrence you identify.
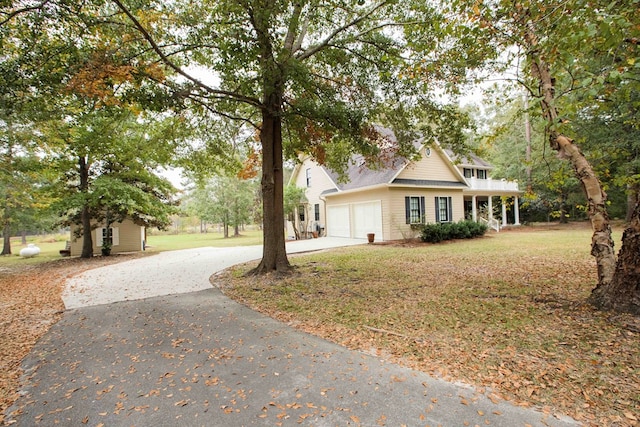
[218,227,640,426]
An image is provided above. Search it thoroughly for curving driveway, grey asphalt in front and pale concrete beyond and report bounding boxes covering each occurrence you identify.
[6,238,579,427]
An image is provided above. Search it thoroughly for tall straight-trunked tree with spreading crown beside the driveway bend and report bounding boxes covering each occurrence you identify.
[101,0,471,273]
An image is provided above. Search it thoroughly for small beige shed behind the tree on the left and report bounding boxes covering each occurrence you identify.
[69,218,146,256]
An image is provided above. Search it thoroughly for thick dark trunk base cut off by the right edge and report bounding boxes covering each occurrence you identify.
[589,203,640,314]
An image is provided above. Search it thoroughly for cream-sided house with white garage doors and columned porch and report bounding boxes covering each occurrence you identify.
[288,137,520,241]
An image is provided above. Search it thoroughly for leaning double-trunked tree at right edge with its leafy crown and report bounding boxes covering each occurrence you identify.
[453,0,640,313]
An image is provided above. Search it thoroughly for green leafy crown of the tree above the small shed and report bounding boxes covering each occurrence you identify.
[43,107,176,232]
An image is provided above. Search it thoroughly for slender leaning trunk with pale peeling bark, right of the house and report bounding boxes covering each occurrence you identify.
[527,29,616,288]
